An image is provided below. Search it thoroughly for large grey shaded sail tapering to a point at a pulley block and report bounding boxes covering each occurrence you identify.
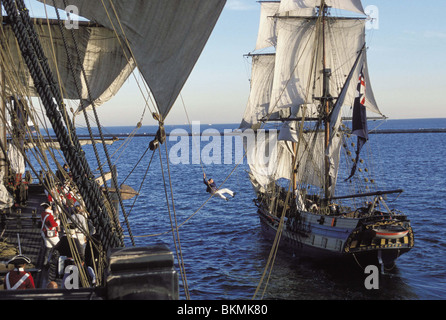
[44,0,226,119]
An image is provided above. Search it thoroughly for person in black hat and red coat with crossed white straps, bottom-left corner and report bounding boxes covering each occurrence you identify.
[4,255,35,290]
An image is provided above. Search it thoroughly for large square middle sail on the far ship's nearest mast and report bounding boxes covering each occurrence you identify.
[271,19,380,113]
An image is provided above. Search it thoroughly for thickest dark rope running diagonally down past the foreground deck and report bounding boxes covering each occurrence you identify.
[3,0,121,255]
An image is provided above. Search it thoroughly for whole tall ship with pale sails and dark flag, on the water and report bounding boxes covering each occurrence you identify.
[240,0,414,267]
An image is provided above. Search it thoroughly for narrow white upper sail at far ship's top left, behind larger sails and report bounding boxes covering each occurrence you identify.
[256,1,280,50]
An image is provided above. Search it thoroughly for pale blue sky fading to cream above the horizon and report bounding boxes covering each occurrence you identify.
[20,0,446,126]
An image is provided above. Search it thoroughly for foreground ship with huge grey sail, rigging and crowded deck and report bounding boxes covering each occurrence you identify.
[0,0,226,299]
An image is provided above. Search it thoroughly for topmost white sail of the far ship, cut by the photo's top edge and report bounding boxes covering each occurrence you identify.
[279,0,365,16]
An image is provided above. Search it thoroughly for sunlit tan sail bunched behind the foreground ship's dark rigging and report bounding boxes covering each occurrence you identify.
[4,21,135,111]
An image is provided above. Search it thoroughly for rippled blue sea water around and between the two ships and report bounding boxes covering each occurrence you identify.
[75,119,446,300]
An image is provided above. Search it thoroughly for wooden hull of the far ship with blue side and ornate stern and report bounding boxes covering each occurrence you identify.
[257,199,414,268]
